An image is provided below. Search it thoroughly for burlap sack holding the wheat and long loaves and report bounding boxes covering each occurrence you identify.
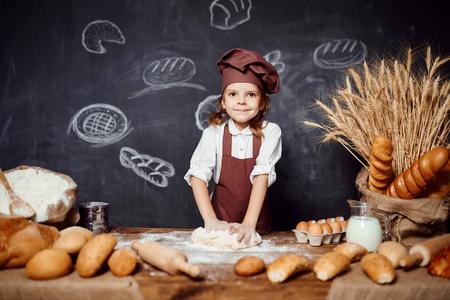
[356,168,450,247]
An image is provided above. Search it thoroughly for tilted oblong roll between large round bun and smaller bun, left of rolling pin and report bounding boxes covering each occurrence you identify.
[76,233,117,277]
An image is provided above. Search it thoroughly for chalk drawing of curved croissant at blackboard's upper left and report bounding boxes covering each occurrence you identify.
[81,20,125,54]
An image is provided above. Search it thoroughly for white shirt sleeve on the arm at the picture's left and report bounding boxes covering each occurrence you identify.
[184,126,217,185]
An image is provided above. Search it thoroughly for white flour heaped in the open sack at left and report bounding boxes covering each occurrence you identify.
[0,168,70,222]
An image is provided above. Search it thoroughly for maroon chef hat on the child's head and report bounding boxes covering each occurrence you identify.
[217,48,280,94]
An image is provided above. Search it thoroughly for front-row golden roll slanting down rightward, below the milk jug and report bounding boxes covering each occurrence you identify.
[361,253,395,284]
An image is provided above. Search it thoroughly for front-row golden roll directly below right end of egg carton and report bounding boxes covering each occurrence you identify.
[313,251,350,281]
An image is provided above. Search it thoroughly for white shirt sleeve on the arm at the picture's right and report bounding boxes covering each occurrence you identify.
[250,123,282,186]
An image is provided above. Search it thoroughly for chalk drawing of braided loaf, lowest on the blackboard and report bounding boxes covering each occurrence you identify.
[119,147,175,187]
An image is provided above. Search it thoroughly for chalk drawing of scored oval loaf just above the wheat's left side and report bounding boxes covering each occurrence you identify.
[313,39,367,69]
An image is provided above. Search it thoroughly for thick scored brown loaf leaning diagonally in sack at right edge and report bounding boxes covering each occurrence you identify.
[385,147,449,199]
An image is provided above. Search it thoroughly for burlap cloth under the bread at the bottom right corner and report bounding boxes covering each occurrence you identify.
[327,262,450,300]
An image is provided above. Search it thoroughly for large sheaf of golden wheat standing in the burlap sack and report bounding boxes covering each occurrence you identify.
[303,46,450,175]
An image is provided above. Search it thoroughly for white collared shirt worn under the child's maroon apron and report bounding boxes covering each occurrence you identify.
[184,119,281,186]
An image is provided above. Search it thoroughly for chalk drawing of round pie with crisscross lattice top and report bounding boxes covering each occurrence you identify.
[67,103,133,147]
